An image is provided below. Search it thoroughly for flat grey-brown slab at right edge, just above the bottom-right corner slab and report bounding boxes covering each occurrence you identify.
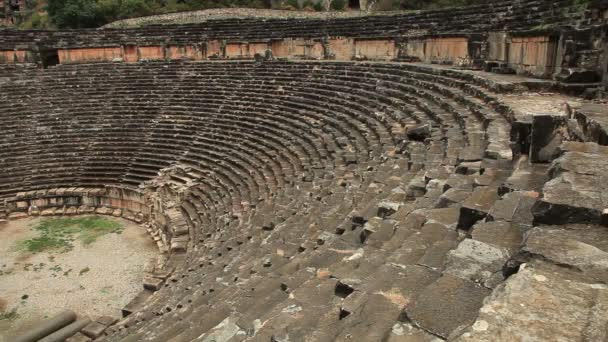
[516,224,608,282]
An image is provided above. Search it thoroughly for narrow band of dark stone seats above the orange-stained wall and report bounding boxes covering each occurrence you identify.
[0,0,585,50]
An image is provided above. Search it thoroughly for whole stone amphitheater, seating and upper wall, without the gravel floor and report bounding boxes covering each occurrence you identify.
[0,0,608,342]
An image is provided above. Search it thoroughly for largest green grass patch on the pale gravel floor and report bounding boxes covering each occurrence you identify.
[17,216,123,253]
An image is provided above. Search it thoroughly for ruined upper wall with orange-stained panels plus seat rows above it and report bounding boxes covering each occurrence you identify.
[0,0,607,83]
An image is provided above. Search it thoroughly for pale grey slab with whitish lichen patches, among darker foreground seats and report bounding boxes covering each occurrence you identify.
[444,239,509,288]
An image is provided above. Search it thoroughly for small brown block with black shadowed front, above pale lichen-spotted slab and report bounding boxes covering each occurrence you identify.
[458,186,499,230]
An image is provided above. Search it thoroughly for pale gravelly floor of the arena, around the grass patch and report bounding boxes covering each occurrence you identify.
[0,218,158,342]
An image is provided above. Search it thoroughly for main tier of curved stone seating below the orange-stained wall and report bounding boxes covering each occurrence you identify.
[0,61,607,341]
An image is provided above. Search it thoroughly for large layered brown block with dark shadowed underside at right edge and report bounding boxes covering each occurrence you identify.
[532,142,608,225]
